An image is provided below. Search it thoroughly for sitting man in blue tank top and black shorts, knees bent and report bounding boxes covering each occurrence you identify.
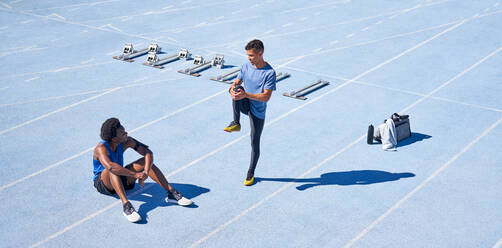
[92,118,192,222]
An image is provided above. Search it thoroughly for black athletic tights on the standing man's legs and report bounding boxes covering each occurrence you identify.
[232,98,265,179]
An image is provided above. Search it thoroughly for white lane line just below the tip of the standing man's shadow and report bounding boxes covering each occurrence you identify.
[344,118,502,248]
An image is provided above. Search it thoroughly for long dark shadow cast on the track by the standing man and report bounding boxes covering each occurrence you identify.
[256,170,415,190]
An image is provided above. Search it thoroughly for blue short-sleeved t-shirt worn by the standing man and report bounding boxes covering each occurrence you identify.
[237,61,275,119]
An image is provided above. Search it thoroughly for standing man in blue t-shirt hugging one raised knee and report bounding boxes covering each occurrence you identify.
[223,40,276,186]
